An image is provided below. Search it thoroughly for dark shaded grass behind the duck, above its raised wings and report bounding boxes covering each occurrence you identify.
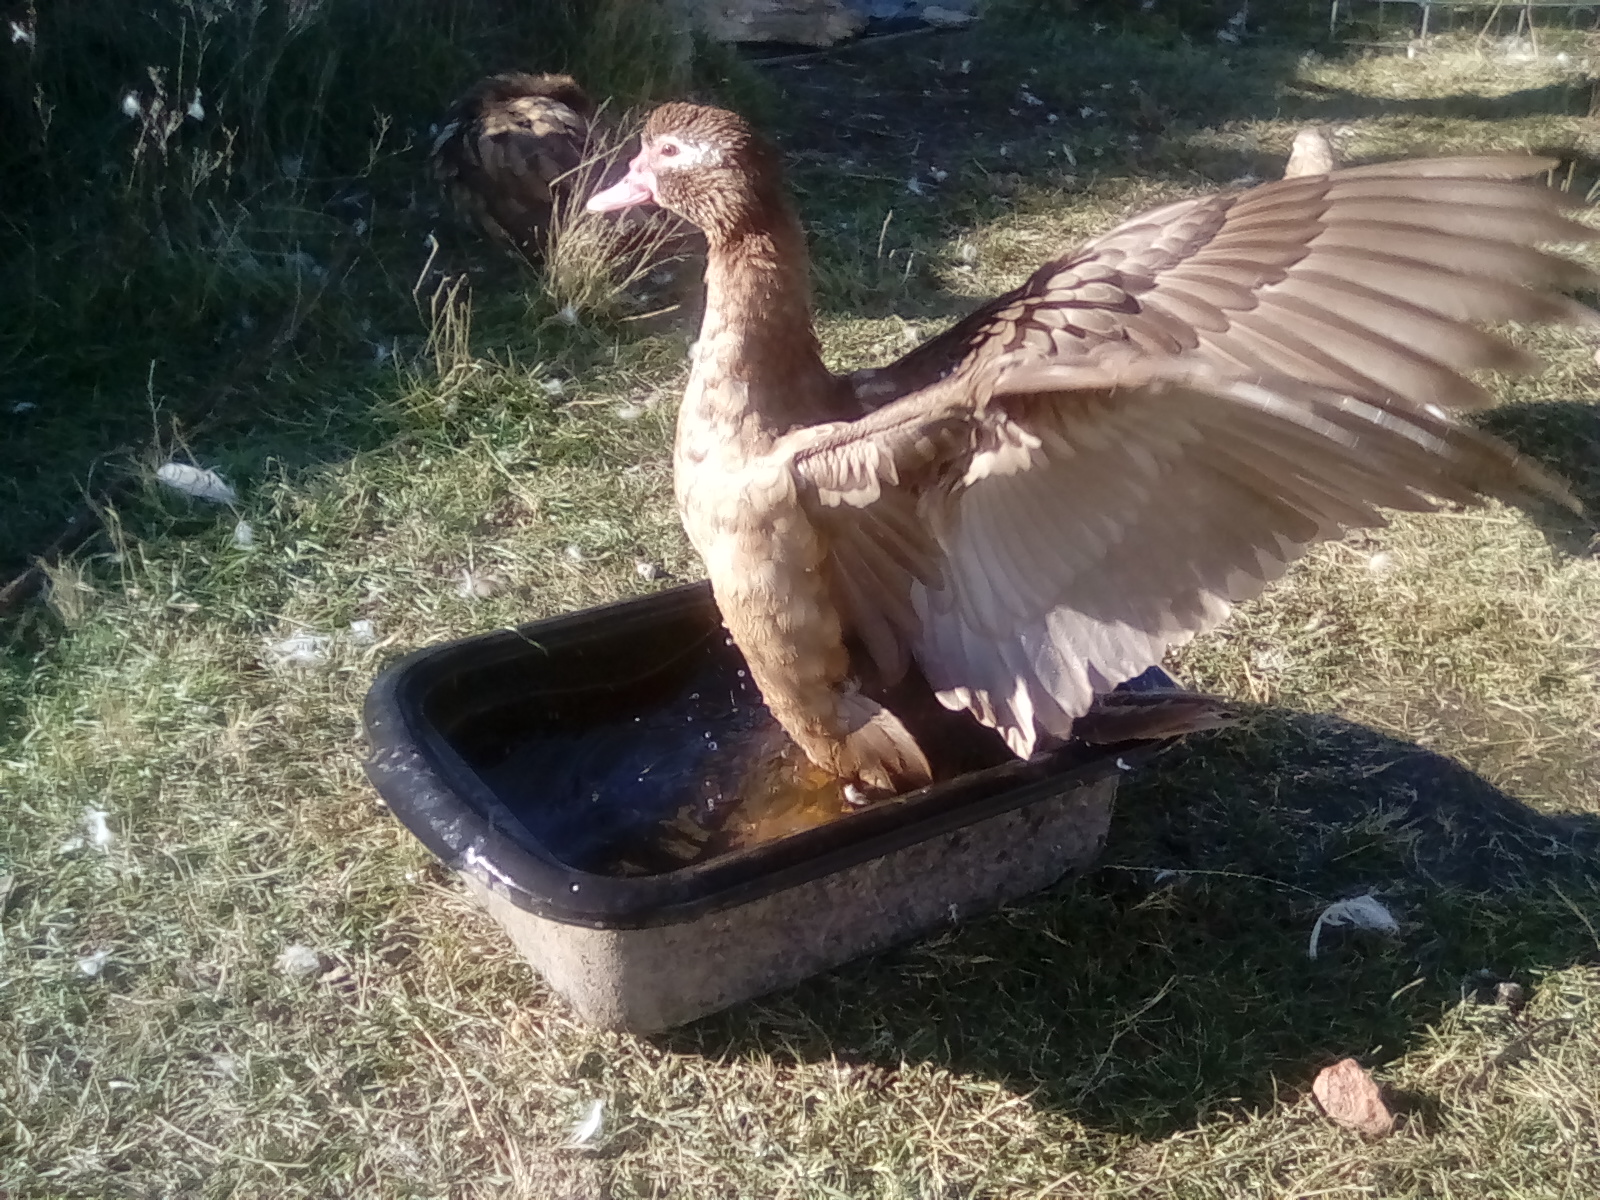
[765,36,1324,318]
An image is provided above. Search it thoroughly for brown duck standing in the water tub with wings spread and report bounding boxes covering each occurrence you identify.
[589,104,1594,792]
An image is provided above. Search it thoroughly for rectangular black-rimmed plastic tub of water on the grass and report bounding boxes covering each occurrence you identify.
[365,584,1171,1030]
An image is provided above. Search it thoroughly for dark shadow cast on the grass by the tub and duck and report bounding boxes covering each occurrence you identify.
[664,712,1600,1138]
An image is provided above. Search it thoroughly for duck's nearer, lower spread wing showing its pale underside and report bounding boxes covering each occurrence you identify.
[779,357,1571,755]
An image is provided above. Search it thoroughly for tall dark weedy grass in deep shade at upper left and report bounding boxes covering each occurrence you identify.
[0,0,741,574]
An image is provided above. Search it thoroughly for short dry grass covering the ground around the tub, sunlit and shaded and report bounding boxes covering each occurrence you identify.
[0,16,1600,1200]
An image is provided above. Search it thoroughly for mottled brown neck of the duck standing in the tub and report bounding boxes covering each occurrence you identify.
[683,213,843,453]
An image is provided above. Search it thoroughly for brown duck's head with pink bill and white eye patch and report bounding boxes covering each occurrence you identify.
[587,104,787,245]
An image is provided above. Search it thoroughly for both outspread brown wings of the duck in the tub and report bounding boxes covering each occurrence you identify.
[806,155,1597,754]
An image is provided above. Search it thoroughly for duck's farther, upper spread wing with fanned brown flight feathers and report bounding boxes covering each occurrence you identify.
[851,155,1592,408]
